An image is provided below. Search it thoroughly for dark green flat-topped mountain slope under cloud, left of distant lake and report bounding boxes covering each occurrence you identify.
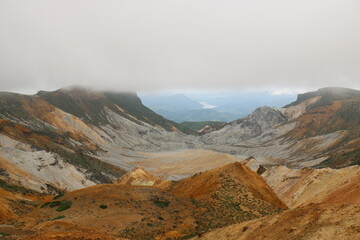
[37,88,196,134]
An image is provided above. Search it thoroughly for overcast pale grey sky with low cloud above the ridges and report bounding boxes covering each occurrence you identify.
[0,0,360,92]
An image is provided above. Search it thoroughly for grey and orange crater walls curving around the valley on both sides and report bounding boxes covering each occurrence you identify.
[0,85,360,192]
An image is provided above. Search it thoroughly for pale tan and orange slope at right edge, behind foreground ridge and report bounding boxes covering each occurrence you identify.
[262,166,360,208]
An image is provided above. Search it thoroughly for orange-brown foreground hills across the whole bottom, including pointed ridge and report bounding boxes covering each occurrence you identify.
[0,159,360,240]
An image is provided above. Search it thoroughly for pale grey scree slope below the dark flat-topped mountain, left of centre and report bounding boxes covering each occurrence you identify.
[90,110,204,170]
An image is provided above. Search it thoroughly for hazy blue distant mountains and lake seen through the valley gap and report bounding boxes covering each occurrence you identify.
[140,91,296,123]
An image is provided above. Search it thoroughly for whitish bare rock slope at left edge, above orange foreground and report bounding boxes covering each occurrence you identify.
[0,135,95,192]
